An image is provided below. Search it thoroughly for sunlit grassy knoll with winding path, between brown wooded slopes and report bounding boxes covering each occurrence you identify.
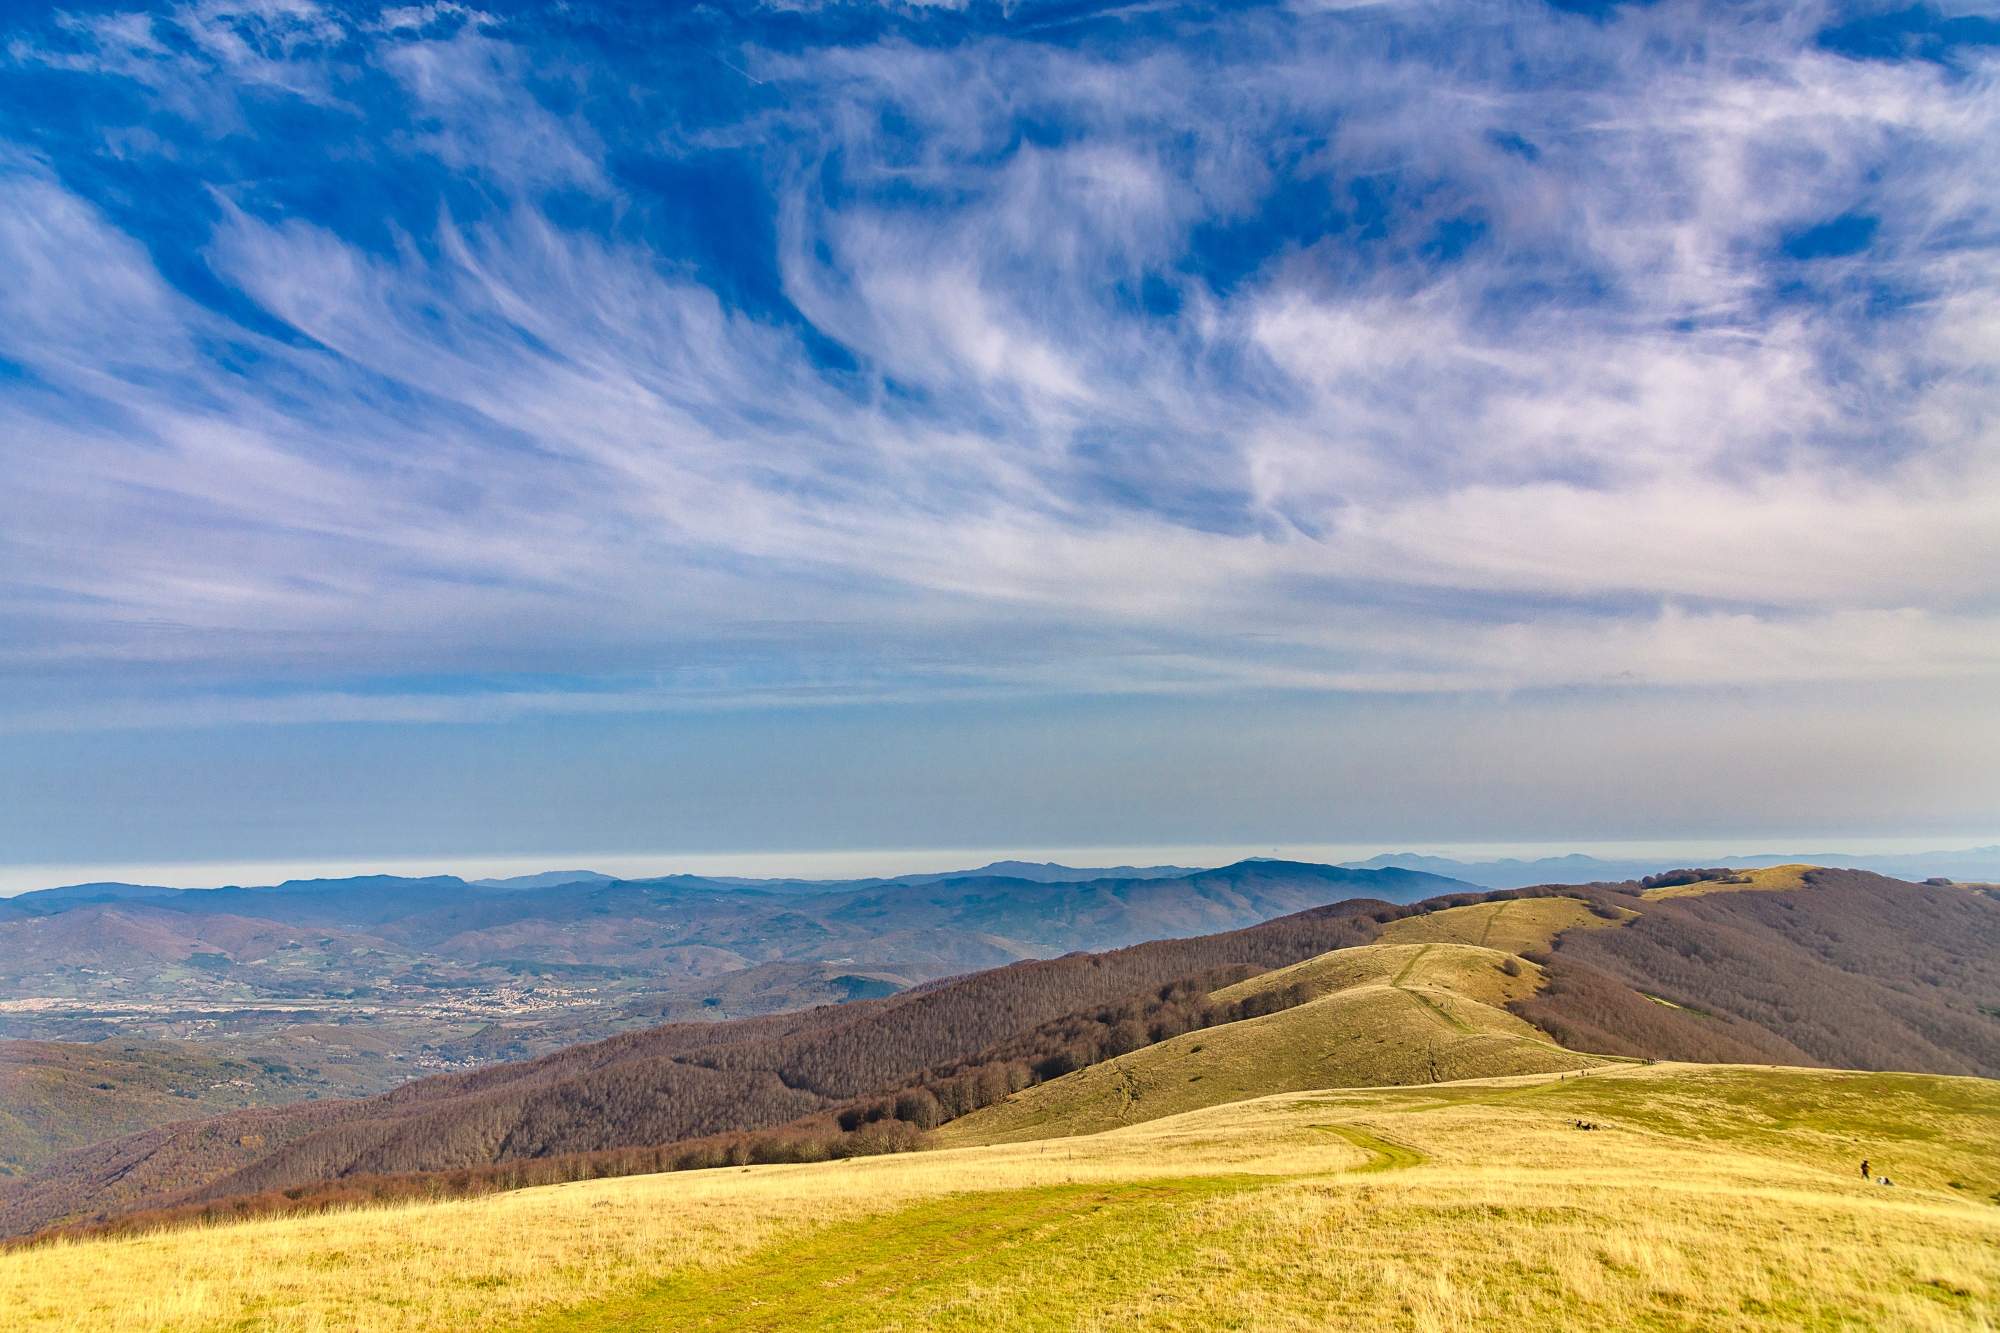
[938,932,1604,1145]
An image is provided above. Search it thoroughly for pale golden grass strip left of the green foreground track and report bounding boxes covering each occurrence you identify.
[0,1088,1366,1333]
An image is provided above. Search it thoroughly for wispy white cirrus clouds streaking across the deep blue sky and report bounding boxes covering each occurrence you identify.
[0,0,2000,717]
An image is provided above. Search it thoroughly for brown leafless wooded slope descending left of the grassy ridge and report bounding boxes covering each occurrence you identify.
[0,888,1394,1233]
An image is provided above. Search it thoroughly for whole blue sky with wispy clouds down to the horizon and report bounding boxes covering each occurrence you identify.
[0,0,2000,887]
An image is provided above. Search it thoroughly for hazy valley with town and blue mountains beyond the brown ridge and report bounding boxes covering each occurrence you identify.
[0,861,1472,1087]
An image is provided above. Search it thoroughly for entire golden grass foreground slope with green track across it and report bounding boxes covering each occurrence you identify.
[0,1065,2000,1333]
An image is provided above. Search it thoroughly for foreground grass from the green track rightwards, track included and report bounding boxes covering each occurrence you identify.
[644,1067,2000,1333]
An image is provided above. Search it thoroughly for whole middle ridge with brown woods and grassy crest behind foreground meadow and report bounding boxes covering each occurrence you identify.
[0,871,2000,1231]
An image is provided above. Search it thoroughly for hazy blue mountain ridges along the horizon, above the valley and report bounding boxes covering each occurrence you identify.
[0,859,1468,940]
